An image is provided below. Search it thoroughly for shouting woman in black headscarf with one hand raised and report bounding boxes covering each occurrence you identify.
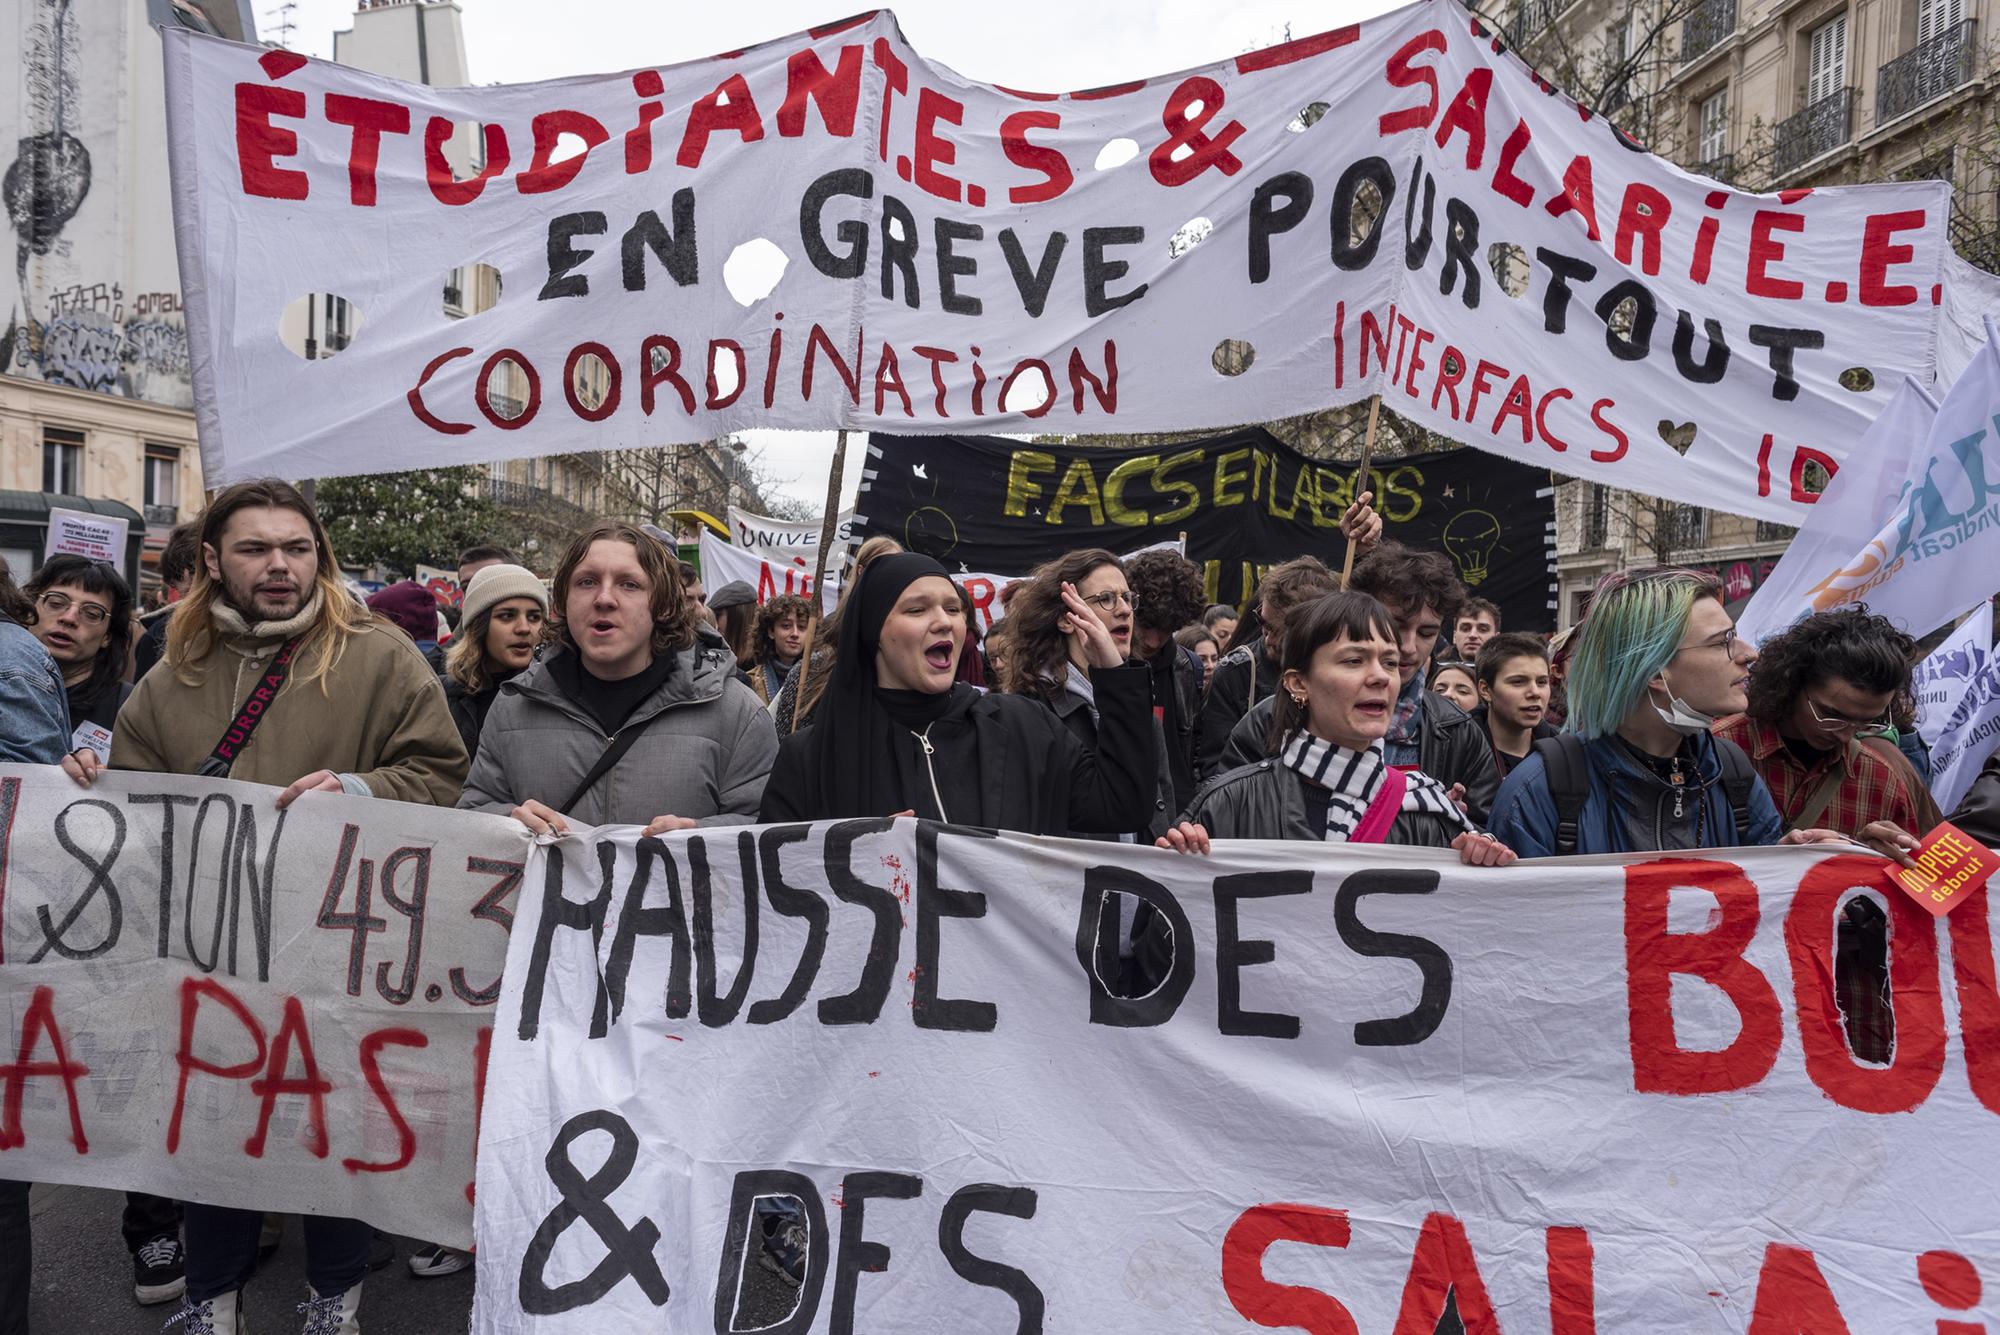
[758,552,1154,833]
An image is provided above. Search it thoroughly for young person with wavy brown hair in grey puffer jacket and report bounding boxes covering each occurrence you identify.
[458,524,778,835]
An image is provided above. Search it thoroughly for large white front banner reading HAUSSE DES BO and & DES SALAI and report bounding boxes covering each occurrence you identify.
[474,819,2000,1335]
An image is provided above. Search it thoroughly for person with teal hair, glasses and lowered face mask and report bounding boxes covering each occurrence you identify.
[1492,568,1840,857]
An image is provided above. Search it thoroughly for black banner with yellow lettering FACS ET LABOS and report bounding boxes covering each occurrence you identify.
[854,428,1556,630]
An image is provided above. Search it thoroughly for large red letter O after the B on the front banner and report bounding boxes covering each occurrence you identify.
[1784,857,1944,1113]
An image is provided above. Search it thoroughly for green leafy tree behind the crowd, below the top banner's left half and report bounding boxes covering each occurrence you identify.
[318,466,504,576]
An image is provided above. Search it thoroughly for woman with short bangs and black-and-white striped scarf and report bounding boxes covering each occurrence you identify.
[1158,594,1514,867]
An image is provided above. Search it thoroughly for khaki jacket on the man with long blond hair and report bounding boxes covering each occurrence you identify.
[112,596,470,807]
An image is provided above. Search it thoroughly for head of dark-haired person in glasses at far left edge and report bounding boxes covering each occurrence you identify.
[22,556,132,759]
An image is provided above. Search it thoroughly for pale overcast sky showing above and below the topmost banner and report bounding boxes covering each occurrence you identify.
[270,0,1394,504]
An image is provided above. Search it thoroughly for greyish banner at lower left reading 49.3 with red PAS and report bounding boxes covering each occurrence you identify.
[0,765,528,1245]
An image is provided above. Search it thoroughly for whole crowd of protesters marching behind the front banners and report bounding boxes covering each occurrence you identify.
[0,471,2000,1335]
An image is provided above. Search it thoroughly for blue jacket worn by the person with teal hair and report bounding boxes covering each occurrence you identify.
[1488,731,1784,857]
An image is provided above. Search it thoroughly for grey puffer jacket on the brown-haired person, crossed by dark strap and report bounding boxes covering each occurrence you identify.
[458,638,778,825]
